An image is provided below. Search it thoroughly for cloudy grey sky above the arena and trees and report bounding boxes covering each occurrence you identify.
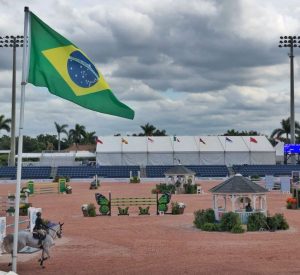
[0,0,300,136]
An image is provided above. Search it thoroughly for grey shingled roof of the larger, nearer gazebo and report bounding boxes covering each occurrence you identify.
[209,175,268,194]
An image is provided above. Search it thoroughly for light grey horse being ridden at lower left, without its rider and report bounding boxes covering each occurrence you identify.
[2,223,63,268]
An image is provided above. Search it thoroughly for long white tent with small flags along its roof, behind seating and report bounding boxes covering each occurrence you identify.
[96,136,275,166]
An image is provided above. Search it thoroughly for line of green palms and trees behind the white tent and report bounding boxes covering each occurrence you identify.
[0,115,300,153]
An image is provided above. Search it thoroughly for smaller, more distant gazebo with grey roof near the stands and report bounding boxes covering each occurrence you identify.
[165,164,196,191]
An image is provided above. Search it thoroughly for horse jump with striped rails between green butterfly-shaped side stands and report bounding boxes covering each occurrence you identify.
[95,192,171,216]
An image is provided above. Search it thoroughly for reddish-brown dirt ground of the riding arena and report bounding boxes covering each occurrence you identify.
[0,181,300,274]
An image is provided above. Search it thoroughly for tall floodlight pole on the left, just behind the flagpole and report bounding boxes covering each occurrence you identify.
[0,35,24,166]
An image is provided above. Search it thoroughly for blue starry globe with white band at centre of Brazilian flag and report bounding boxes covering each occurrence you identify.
[67,51,99,88]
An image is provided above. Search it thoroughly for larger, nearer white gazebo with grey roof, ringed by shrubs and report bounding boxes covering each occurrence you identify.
[209,174,268,223]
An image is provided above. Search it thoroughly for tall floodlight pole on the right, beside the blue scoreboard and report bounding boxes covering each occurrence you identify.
[279,35,300,164]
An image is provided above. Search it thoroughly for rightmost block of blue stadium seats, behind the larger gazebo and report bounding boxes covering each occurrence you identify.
[232,165,300,177]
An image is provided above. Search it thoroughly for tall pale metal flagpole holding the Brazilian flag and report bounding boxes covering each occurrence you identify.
[12,7,29,273]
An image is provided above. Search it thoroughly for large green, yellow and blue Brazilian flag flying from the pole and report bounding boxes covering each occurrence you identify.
[28,12,134,119]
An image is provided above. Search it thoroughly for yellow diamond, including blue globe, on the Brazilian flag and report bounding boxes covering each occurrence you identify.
[42,45,110,96]
